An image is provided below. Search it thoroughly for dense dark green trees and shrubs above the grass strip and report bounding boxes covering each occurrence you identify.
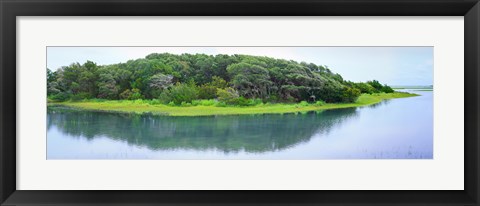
[47,53,393,105]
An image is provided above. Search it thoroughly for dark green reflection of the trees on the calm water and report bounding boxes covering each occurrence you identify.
[47,108,357,153]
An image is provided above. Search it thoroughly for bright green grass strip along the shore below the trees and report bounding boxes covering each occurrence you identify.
[48,92,418,116]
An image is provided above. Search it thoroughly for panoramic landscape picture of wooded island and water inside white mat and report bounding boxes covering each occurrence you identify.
[46,46,434,160]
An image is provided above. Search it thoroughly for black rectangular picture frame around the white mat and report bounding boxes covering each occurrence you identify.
[0,0,480,205]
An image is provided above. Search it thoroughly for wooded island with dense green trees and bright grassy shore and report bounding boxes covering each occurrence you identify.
[47,53,416,116]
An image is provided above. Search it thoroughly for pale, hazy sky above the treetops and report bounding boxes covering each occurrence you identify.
[47,47,433,86]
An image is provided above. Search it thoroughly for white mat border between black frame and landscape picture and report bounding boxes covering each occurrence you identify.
[17,17,464,190]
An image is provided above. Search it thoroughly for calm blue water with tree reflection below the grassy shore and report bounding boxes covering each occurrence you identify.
[47,91,433,159]
